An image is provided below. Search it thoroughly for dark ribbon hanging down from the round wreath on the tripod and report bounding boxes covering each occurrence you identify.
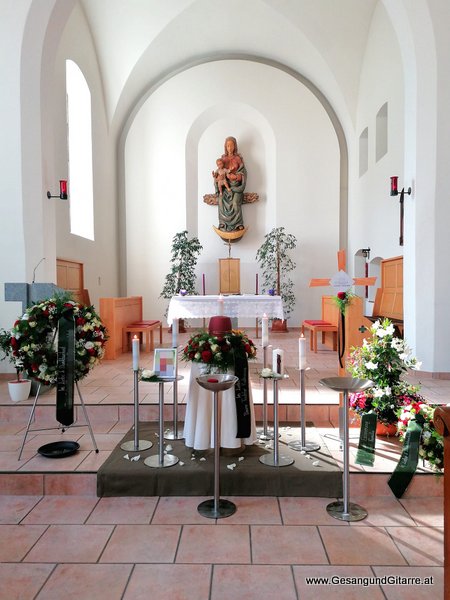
[56,315,75,426]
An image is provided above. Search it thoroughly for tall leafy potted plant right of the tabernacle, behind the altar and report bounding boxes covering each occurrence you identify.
[256,227,297,331]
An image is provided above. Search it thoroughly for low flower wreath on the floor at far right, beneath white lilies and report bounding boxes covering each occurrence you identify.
[397,402,444,472]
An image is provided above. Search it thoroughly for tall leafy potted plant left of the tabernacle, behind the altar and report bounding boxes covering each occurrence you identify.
[159,230,203,332]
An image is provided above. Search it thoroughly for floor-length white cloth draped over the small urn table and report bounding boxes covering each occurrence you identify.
[184,363,256,450]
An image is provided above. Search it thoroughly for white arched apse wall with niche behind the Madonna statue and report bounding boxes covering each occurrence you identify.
[124,61,339,326]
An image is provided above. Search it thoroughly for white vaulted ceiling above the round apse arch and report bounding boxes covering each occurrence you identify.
[80,0,379,131]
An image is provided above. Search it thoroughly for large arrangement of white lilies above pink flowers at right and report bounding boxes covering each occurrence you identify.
[347,319,423,424]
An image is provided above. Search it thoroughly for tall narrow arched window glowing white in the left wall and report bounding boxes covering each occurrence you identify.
[66,60,94,240]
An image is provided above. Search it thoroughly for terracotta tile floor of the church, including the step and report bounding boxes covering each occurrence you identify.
[0,331,444,600]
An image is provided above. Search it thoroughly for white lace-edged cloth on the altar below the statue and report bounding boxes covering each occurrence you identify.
[167,294,284,325]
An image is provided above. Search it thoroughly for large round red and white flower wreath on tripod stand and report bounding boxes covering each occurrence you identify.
[4,297,107,385]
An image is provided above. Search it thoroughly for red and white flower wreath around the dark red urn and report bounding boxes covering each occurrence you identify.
[181,329,256,372]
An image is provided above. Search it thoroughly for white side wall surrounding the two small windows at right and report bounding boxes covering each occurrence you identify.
[349,5,404,264]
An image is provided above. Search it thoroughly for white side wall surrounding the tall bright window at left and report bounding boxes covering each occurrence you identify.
[50,5,118,308]
